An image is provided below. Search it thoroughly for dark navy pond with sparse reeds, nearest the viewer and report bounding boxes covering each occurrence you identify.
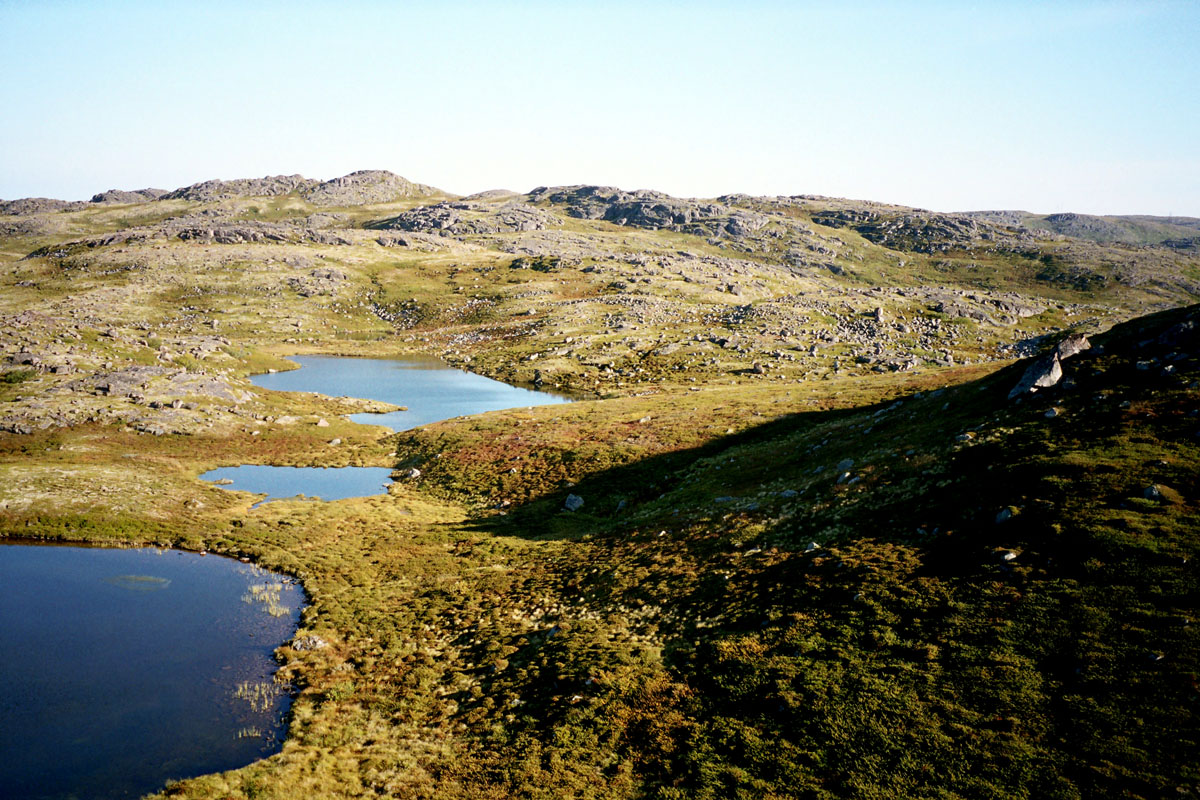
[0,543,304,800]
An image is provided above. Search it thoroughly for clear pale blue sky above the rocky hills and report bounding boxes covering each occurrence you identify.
[0,0,1200,216]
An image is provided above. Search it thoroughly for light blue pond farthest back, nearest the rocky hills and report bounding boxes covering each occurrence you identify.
[251,355,570,431]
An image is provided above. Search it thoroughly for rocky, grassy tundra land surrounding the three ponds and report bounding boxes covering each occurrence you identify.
[0,172,1200,800]
